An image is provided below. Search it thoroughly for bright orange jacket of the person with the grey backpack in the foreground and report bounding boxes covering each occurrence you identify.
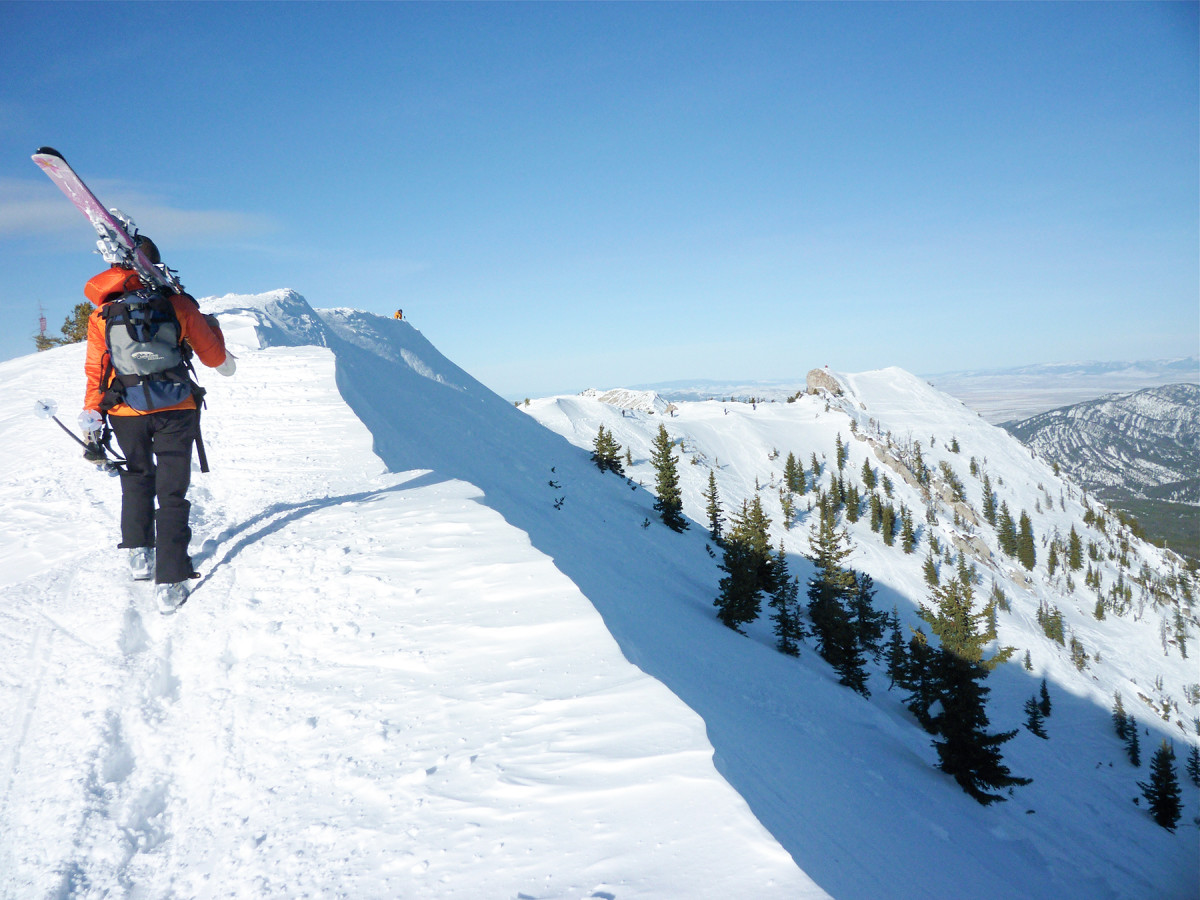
[83,265,226,415]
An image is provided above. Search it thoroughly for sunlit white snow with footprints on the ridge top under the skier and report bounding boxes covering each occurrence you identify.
[0,314,823,900]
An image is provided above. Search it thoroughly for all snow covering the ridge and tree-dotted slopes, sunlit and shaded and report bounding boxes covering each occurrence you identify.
[0,292,1198,900]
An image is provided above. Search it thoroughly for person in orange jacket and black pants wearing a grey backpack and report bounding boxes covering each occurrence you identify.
[79,236,236,613]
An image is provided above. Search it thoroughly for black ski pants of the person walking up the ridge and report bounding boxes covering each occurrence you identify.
[108,409,200,584]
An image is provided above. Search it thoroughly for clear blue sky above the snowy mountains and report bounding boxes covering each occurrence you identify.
[0,2,1200,397]
